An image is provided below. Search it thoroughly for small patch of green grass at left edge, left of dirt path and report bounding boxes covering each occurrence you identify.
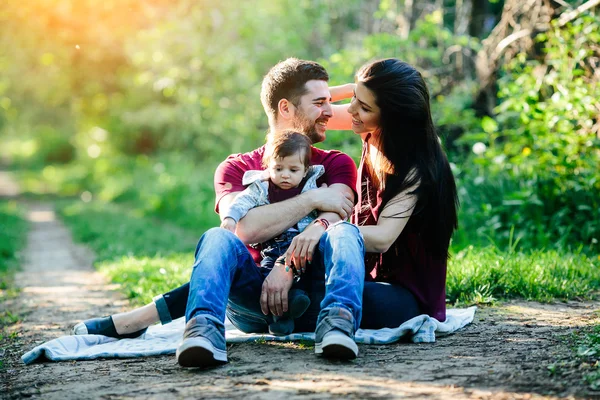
[0,200,27,290]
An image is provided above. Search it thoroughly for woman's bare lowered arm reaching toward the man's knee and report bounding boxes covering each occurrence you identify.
[358,185,417,253]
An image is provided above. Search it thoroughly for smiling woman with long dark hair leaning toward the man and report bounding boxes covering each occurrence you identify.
[74,59,458,346]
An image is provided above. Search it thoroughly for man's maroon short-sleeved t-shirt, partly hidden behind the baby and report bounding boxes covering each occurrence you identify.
[214,146,356,263]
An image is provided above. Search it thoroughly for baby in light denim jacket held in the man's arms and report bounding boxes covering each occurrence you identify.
[221,131,325,335]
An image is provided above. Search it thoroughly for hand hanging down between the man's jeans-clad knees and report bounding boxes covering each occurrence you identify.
[260,264,294,317]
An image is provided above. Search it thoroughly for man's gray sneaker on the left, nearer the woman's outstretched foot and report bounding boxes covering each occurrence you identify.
[176,315,227,367]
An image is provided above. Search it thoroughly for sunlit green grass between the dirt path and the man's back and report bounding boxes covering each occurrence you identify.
[57,201,202,304]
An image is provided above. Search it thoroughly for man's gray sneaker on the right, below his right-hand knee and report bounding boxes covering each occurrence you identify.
[315,307,358,360]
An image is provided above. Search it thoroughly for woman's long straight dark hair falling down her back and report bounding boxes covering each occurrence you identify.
[356,59,458,258]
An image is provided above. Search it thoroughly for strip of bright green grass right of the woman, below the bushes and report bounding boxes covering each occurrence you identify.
[447,246,600,304]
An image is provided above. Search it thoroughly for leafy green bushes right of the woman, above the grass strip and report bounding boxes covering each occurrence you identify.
[457,17,600,254]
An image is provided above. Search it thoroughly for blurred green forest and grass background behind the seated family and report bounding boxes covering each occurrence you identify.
[0,0,600,303]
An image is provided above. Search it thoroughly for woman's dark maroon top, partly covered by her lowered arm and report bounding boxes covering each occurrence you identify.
[352,142,447,322]
